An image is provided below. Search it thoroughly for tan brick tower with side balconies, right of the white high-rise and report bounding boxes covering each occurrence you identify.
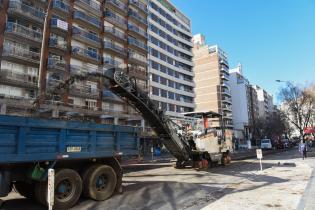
[193,35,233,129]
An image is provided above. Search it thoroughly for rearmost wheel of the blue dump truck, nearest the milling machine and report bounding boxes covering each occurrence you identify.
[82,165,117,201]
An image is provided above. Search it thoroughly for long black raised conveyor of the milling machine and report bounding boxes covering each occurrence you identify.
[103,69,190,161]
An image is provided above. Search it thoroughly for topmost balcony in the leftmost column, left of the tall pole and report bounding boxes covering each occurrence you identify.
[8,0,45,24]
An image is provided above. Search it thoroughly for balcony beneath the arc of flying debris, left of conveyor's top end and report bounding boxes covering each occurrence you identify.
[70,83,100,99]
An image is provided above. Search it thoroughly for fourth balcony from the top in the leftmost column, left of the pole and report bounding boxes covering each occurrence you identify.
[0,69,38,88]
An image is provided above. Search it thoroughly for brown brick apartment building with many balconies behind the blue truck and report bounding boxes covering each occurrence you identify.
[0,0,148,124]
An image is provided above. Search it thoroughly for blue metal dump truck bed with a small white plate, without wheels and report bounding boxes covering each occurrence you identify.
[0,115,138,165]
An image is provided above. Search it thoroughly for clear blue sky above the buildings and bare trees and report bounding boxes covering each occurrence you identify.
[171,0,315,101]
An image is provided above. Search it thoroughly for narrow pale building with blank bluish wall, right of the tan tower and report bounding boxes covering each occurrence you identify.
[229,64,252,141]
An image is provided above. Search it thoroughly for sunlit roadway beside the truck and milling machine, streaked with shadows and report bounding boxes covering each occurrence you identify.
[0,150,315,210]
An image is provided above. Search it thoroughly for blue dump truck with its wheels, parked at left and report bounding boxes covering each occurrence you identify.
[0,115,138,209]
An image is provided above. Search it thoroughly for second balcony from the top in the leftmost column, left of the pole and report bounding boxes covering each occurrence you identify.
[5,22,42,45]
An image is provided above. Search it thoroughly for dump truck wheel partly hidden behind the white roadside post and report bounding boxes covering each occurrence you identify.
[35,169,82,210]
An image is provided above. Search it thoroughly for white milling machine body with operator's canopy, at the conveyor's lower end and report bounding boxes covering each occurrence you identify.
[176,111,232,167]
